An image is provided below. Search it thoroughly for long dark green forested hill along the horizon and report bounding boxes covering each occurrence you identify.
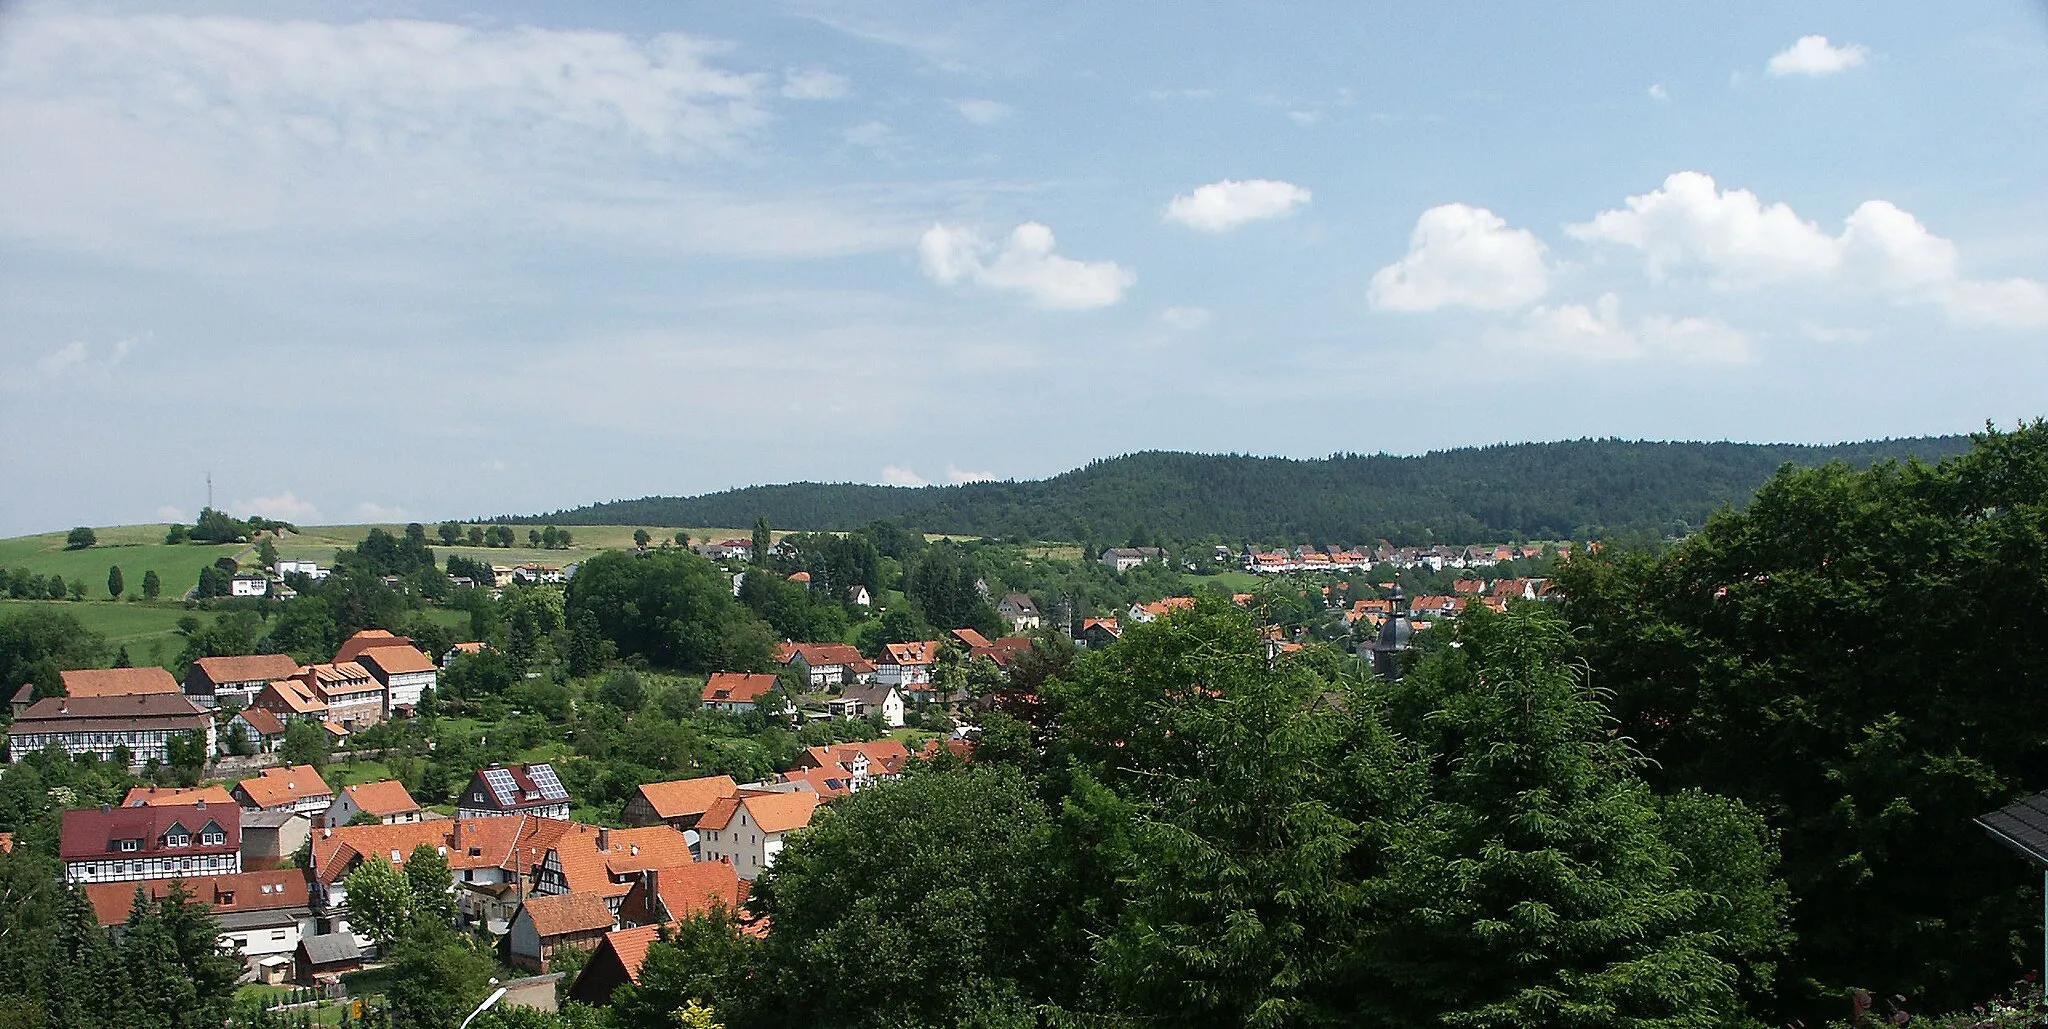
[508,437,1970,543]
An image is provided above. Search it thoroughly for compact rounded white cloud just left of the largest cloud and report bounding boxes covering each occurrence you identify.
[1368,203,1550,312]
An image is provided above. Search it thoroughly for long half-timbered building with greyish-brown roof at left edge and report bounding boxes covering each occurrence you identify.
[6,696,215,769]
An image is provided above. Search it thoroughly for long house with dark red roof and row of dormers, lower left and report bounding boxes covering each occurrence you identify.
[57,801,242,883]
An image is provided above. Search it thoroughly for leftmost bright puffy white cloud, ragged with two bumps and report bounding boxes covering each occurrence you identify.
[918,221,1137,312]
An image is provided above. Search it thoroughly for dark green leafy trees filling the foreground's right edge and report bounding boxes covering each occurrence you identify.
[1563,422,2048,1015]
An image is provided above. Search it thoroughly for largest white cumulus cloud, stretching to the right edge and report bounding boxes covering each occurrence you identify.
[1565,172,2048,328]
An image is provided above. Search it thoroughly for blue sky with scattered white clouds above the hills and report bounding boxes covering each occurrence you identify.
[0,0,2048,535]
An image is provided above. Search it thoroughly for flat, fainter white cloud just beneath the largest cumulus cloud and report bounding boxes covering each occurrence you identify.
[1485,293,1753,363]
